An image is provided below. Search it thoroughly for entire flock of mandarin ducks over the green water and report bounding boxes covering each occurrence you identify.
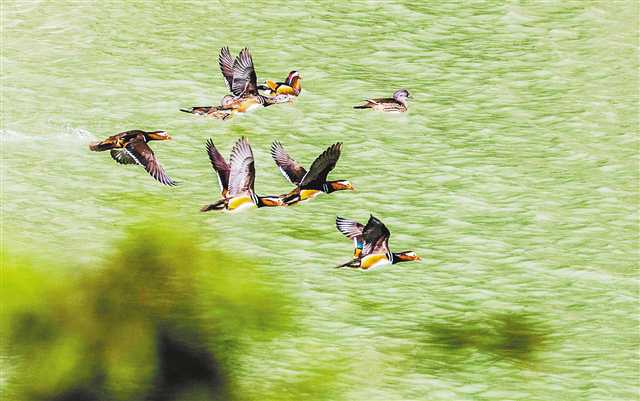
[89,47,420,270]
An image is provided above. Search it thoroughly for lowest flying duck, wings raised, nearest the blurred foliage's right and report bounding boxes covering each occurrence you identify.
[336,215,421,270]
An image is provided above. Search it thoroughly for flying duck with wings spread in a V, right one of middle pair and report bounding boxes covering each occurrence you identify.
[271,141,354,205]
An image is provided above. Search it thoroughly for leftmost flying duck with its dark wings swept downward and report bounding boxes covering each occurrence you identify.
[89,130,176,186]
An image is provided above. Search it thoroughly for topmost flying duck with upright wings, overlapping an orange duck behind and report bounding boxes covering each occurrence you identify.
[180,47,288,120]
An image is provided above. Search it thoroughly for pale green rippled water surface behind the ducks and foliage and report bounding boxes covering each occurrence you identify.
[2,1,639,400]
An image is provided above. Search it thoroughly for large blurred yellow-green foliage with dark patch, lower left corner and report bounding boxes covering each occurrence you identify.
[0,225,292,401]
